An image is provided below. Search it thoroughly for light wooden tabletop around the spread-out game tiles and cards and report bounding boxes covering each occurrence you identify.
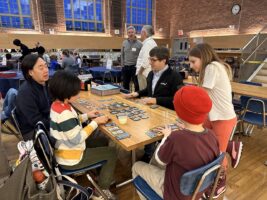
[72,91,177,151]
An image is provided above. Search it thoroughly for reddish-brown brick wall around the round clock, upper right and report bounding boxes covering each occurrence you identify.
[165,0,267,38]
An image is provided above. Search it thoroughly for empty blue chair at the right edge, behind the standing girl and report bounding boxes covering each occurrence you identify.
[241,98,267,135]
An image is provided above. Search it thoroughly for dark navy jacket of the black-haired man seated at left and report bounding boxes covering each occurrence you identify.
[16,80,51,137]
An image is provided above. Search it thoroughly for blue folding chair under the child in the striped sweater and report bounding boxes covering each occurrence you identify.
[34,122,108,200]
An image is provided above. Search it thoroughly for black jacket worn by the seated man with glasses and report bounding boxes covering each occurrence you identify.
[138,67,184,110]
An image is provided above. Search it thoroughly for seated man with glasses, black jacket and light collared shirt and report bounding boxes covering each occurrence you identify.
[125,47,183,109]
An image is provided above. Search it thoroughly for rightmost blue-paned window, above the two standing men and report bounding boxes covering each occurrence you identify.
[126,0,152,33]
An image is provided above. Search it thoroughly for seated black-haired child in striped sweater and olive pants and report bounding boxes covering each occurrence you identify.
[49,71,116,199]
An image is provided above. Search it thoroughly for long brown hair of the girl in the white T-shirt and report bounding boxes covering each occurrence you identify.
[189,43,232,85]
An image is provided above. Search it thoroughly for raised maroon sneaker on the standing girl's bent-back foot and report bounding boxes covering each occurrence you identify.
[226,141,243,168]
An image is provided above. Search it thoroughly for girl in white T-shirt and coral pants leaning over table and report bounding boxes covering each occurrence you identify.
[189,43,243,198]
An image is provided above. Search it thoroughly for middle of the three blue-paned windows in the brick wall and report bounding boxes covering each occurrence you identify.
[64,0,104,32]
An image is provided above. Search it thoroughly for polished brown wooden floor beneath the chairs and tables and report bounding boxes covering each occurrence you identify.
[1,126,267,200]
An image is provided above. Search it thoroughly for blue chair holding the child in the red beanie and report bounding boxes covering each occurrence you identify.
[133,153,225,200]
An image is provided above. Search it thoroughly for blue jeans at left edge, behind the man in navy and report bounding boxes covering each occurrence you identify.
[1,88,18,121]
